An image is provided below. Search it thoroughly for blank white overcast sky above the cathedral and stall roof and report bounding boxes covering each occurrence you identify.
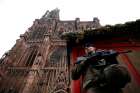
[0,0,140,57]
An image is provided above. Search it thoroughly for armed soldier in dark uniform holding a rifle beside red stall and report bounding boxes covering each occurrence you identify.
[72,45,130,93]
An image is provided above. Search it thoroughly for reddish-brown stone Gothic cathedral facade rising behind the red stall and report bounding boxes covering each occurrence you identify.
[0,9,101,93]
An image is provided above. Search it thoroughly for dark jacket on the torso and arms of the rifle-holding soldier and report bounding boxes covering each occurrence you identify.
[71,51,117,89]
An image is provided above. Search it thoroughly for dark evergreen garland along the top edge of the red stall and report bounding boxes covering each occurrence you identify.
[61,19,140,44]
